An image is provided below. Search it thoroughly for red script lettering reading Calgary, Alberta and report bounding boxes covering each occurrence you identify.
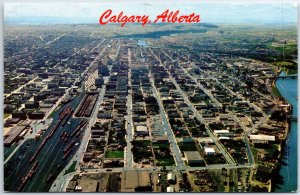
[99,9,200,27]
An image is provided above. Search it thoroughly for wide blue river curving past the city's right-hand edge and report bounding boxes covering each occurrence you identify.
[274,72,298,192]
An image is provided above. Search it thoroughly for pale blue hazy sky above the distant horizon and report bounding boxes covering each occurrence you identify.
[4,2,297,24]
